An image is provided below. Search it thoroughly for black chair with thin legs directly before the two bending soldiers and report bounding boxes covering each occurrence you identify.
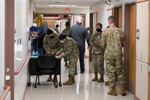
[34,55,62,88]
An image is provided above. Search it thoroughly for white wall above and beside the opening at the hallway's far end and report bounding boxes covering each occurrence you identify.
[36,7,90,27]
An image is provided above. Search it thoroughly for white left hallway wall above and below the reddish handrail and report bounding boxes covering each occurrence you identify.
[14,0,34,100]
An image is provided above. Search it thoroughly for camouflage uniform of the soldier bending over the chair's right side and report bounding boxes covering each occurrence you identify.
[60,37,79,76]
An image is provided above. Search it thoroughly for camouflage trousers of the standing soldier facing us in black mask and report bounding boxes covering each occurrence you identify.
[92,55,104,75]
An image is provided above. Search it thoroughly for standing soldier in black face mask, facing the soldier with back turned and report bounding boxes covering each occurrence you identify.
[90,23,104,82]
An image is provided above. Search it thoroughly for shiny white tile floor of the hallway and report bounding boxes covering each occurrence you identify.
[25,59,134,100]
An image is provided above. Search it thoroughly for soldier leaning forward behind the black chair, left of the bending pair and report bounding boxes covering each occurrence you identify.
[43,29,61,82]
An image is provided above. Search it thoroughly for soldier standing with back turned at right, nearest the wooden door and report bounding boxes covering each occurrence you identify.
[102,16,126,96]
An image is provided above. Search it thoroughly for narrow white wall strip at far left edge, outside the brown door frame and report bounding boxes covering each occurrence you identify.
[0,0,5,95]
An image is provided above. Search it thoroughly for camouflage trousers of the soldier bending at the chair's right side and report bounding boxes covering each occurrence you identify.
[67,55,78,76]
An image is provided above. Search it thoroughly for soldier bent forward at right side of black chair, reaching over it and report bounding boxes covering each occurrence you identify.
[56,35,79,85]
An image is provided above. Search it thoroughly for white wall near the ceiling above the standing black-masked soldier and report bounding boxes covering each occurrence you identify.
[90,2,112,29]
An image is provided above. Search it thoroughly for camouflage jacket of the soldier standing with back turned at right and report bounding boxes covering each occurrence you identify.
[101,26,124,59]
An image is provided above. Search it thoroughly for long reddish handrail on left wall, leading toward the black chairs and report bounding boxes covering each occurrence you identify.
[14,50,31,75]
